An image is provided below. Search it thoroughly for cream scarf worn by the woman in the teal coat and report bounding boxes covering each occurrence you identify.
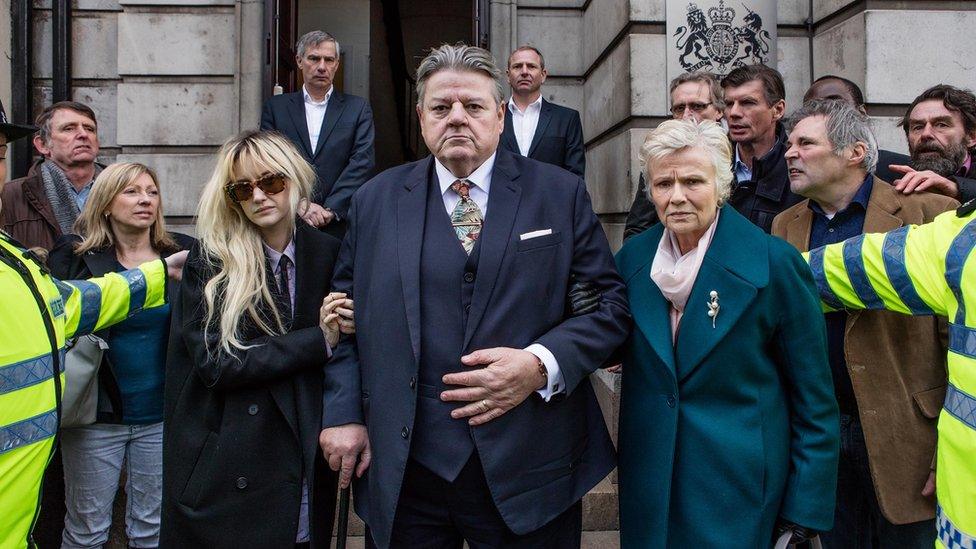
[651,210,721,345]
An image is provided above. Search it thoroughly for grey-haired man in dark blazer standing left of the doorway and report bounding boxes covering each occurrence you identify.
[261,30,376,238]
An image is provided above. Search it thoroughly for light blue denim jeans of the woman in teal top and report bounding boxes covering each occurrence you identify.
[61,423,163,549]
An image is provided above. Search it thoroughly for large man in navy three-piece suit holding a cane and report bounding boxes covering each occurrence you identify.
[320,45,630,549]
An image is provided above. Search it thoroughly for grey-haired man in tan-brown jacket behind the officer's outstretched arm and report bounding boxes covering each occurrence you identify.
[772,100,958,549]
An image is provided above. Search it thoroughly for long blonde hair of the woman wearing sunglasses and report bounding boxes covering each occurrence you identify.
[197,131,315,355]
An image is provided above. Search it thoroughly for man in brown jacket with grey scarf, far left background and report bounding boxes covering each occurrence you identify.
[0,101,101,250]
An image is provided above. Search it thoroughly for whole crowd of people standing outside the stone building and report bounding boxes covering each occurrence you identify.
[0,31,976,549]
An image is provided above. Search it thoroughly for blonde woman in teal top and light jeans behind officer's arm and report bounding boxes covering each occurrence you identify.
[48,163,193,548]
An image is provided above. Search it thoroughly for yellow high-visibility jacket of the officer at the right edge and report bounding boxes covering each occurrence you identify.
[808,207,976,549]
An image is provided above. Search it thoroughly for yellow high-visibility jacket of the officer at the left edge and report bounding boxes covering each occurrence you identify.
[0,232,166,549]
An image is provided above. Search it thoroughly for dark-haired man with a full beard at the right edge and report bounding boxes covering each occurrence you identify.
[891,84,976,202]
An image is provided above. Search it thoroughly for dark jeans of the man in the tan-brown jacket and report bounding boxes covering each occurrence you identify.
[820,414,936,549]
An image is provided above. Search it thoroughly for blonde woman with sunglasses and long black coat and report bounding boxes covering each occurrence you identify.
[160,132,353,548]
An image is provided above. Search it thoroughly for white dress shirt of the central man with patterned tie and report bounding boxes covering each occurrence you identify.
[434,154,565,402]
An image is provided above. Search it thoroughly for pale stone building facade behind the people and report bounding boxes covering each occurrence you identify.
[0,0,976,529]
